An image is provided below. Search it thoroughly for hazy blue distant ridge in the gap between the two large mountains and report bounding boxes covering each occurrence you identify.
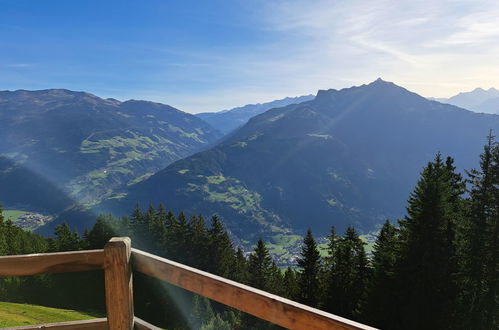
[196,95,314,134]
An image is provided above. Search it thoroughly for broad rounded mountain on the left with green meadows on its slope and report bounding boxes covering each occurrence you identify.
[0,89,220,203]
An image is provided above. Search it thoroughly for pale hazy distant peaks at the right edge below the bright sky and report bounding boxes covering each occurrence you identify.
[430,88,499,114]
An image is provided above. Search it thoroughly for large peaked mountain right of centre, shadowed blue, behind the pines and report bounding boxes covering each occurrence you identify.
[96,80,499,237]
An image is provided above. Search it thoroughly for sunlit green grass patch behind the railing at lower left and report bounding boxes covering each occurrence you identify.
[0,302,102,328]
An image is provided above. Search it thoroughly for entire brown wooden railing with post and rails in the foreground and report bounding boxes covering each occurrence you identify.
[0,237,374,330]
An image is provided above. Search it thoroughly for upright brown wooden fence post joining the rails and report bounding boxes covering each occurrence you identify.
[104,237,133,330]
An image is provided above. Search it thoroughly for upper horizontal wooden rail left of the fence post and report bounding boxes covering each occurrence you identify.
[0,250,104,276]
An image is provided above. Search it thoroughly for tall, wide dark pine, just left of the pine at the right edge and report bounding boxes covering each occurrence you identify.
[396,154,461,329]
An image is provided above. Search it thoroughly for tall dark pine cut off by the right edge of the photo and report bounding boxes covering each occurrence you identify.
[459,135,499,329]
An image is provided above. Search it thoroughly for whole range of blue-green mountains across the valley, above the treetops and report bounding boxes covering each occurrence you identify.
[4,79,499,239]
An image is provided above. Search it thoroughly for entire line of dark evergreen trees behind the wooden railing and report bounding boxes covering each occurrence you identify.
[0,136,499,330]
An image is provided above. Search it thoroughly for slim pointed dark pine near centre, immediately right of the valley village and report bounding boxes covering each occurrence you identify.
[298,229,321,307]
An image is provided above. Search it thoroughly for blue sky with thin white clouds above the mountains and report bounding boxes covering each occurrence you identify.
[0,0,499,113]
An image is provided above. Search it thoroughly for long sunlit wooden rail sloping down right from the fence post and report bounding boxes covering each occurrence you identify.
[132,249,374,330]
